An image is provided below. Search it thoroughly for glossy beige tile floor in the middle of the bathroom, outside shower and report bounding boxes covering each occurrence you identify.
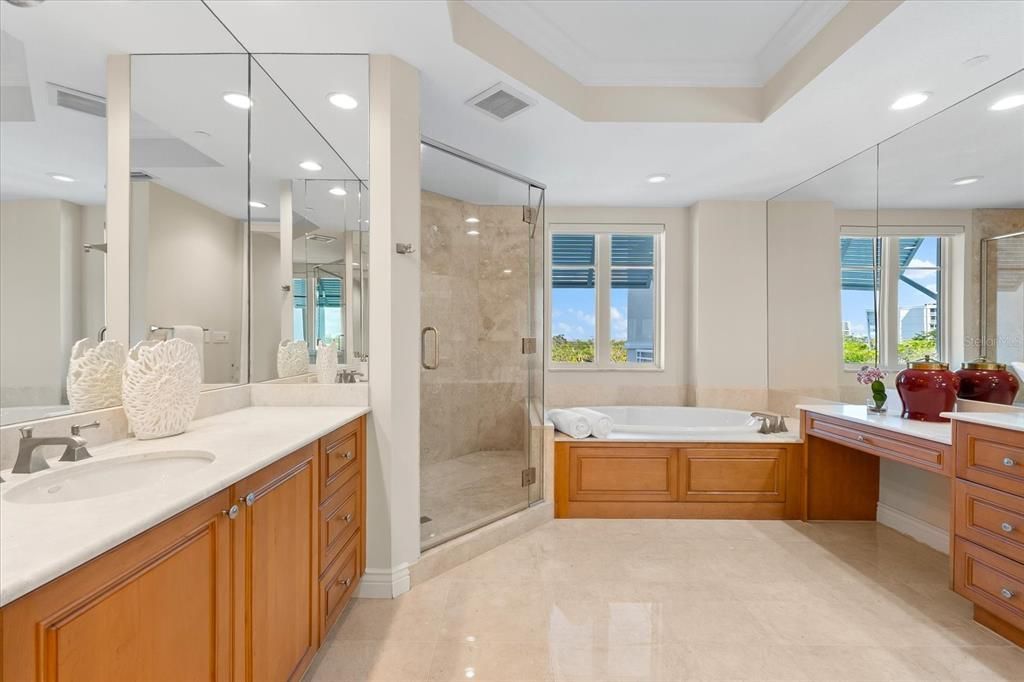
[307,520,1024,682]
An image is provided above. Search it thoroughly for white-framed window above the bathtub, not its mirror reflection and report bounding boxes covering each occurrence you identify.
[549,225,664,370]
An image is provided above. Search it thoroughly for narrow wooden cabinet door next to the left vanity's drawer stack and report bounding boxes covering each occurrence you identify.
[232,442,318,682]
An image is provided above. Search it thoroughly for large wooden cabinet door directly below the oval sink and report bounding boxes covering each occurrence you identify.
[0,491,231,682]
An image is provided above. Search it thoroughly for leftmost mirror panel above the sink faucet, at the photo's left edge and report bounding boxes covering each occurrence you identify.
[0,25,108,425]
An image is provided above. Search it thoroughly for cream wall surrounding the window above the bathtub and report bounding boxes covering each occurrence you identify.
[545,206,690,409]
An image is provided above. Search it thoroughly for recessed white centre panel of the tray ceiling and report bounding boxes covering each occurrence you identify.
[470,0,846,87]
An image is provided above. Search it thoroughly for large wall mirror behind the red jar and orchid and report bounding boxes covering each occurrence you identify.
[768,72,1024,414]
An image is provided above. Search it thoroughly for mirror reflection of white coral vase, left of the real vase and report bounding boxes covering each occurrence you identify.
[68,338,125,412]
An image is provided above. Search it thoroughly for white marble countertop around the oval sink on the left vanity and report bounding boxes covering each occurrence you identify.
[0,407,370,606]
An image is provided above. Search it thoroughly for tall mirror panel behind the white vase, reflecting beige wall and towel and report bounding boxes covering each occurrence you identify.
[130,54,249,389]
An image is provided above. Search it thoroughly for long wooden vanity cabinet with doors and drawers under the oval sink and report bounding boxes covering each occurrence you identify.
[0,411,366,682]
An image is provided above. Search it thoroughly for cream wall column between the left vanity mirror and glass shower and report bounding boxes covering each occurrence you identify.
[359,55,420,598]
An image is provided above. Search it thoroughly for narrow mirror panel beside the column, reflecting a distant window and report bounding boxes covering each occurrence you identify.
[250,54,369,382]
